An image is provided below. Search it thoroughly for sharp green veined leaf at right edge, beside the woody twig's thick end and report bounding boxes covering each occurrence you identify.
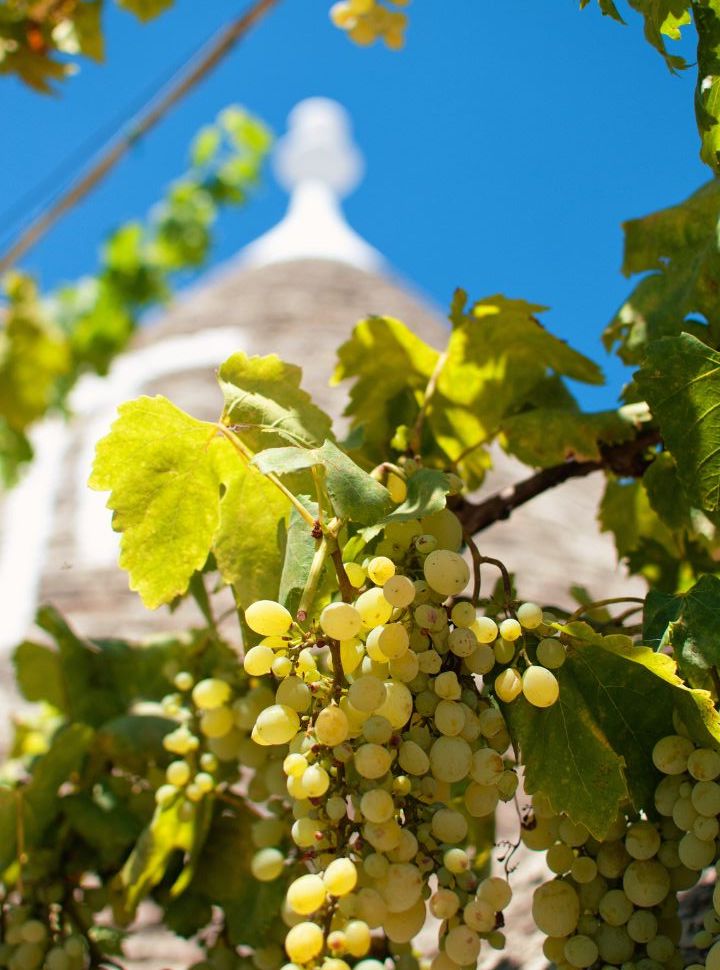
[636,333,720,512]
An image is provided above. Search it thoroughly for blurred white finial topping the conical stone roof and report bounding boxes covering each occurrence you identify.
[241,98,383,270]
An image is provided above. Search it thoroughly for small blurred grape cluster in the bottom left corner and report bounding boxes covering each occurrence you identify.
[0,903,89,970]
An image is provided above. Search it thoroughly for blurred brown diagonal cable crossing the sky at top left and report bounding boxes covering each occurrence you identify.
[0,0,279,273]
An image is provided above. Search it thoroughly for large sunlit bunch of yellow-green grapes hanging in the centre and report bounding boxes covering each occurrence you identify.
[239,502,564,970]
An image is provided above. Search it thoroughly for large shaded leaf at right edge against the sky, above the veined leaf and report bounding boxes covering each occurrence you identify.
[603,180,720,364]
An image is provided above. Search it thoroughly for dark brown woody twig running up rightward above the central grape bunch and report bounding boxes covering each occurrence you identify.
[453,428,661,535]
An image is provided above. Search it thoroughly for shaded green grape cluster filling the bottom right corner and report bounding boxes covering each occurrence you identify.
[522,734,720,970]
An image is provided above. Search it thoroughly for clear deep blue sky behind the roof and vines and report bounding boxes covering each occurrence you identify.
[0,0,709,407]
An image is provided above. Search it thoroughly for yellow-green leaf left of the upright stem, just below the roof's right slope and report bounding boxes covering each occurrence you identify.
[332,316,440,463]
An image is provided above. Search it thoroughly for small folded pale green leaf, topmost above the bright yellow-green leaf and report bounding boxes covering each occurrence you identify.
[218,353,331,451]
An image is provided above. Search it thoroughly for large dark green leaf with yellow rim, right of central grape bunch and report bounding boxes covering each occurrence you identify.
[505,623,720,838]
